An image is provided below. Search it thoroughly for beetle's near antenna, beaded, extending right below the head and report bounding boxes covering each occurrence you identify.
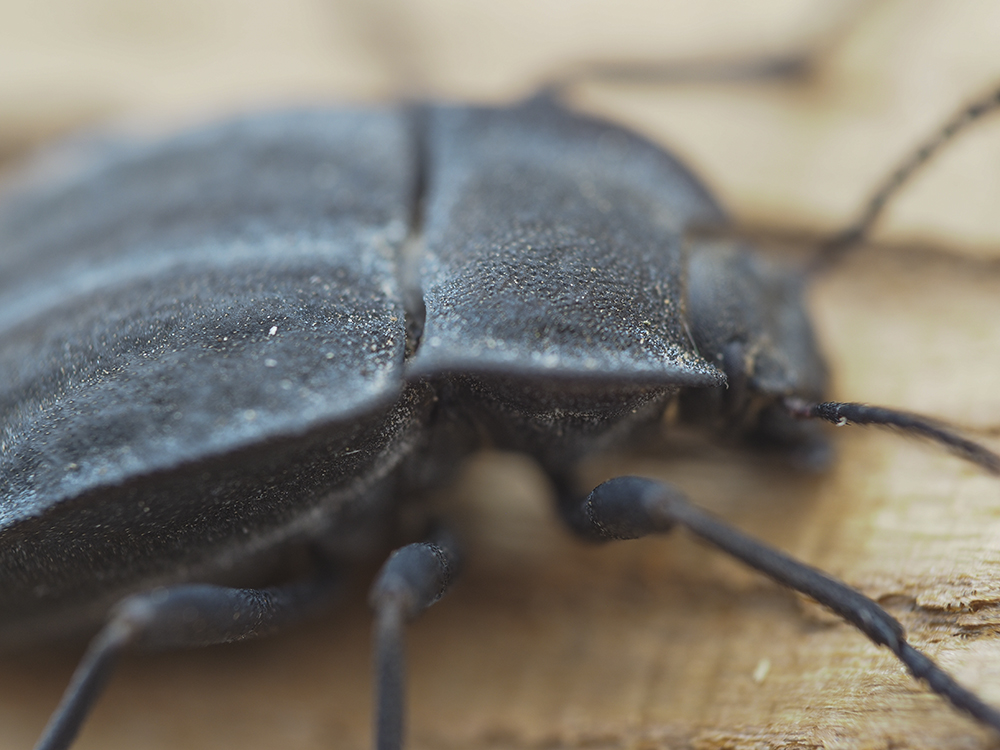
[784,398,1000,475]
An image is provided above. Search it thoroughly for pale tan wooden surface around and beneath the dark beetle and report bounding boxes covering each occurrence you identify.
[0,0,1000,750]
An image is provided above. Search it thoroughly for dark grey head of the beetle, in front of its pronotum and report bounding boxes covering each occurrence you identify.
[681,241,830,468]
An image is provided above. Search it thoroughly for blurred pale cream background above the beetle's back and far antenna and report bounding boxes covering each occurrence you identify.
[0,0,1000,256]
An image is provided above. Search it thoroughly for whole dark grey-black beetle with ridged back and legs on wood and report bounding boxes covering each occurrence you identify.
[0,83,1000,750]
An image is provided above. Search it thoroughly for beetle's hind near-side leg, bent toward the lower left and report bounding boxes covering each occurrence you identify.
[35,571,338,750]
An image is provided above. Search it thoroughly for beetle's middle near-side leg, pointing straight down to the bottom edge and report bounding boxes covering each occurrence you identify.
[369,534,459,750]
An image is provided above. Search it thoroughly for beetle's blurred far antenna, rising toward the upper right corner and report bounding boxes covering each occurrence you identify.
[811,87,1000,271]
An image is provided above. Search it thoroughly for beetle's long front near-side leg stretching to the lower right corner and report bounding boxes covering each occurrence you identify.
[561,477,1000,731]
